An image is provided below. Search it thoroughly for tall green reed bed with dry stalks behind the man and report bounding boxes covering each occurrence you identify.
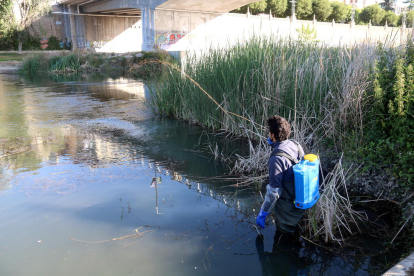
[153,38,377,153]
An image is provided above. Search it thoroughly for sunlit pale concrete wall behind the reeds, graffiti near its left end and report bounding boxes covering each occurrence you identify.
[155,10,413,51]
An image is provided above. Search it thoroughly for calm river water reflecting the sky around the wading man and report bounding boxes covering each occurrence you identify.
[0,75,400,276]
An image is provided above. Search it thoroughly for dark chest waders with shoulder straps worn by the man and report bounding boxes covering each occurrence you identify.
[271,141,305,234]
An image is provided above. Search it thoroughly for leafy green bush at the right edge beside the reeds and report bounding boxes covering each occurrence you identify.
[369,41,414,187]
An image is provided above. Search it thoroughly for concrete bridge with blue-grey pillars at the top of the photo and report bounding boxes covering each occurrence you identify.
[55,0,255,52]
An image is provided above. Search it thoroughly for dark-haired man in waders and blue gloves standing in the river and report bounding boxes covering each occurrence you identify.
[256,115,305,242]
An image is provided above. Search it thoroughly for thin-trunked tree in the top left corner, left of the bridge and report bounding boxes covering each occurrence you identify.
[0,0,51,52]
